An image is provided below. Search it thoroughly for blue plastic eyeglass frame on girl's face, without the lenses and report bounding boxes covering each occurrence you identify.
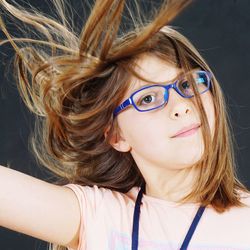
[113,70,213,117]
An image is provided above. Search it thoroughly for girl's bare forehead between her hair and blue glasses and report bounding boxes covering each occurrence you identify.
[129,55,183,94]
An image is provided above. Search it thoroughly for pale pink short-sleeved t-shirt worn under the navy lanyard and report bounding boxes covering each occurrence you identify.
[65,184,250,250]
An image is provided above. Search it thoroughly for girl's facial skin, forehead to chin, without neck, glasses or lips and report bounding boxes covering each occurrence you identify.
[113,55,214,173]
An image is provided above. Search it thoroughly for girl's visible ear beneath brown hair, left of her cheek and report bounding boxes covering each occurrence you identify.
[104,126,131,152]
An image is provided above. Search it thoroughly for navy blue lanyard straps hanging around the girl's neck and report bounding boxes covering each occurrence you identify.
[132,182,205,250]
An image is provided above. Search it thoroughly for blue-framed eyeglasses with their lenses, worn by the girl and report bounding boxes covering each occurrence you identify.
[113,70,212,116]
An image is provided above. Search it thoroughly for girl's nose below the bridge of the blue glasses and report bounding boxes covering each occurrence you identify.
[167,88,192,119]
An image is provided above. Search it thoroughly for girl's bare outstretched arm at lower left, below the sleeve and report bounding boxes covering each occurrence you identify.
[0,166,80,248]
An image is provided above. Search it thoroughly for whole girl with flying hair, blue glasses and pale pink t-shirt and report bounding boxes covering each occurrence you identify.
[0,0,250,250]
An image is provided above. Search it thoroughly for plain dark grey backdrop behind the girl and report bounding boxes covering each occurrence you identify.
[0,0,250,250]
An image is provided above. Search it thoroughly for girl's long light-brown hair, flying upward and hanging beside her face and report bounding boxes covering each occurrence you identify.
[0,0,249,249]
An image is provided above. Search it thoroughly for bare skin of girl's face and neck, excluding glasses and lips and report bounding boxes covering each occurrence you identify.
[108,55,215,202]
